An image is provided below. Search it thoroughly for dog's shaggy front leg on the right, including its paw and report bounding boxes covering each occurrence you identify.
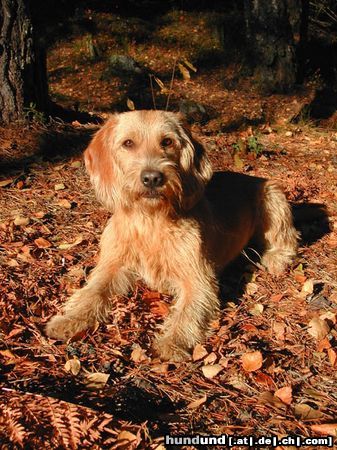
[154,271,219,361]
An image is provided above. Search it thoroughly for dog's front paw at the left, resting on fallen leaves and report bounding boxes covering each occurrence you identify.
[46,315,90,341]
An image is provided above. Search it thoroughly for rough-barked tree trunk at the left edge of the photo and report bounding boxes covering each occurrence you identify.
[0,0,48,123]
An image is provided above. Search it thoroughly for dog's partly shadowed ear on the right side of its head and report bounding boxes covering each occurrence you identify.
[180,118,213,210]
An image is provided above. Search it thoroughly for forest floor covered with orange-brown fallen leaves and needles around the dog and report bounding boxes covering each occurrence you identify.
[0,7,337,449]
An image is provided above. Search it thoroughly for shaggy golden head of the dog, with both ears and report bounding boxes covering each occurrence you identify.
[84,111,212,214]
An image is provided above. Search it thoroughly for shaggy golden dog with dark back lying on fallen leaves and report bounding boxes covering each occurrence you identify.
[46,110,298,361]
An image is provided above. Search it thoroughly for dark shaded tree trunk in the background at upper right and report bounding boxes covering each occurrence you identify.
[245,0,301,92]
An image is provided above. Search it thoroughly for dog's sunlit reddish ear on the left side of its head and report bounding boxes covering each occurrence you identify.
[84,116,117,210]
